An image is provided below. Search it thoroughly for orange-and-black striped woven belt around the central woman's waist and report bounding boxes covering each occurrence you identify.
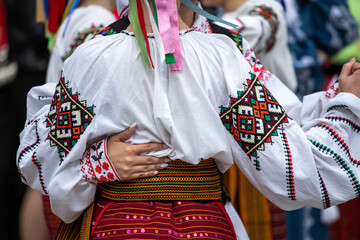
[98,158,221,201]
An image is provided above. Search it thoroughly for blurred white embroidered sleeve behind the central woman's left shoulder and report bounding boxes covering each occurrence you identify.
[46,5,117,83]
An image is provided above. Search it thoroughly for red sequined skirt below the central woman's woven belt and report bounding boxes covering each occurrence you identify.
[91,199,236,240]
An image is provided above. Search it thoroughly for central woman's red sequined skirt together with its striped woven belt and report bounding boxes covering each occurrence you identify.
[57,159,236,240]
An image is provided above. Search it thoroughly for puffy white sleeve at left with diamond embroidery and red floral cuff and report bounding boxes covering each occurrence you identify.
[17,51,120,222]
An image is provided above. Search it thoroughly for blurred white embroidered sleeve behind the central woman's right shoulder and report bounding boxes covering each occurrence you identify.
[220,0,297,91]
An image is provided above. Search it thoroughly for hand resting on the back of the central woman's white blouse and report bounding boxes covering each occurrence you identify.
[107,126,170,180]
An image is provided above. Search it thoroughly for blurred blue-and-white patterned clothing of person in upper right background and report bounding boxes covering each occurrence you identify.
[285,0,359,98]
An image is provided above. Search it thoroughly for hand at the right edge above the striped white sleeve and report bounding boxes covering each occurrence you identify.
[339,58,360,97]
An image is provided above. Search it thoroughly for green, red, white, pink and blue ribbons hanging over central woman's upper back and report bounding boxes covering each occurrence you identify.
[124,0,237,71]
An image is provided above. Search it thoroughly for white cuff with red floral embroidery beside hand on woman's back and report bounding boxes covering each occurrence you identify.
[80,138,121,184]
